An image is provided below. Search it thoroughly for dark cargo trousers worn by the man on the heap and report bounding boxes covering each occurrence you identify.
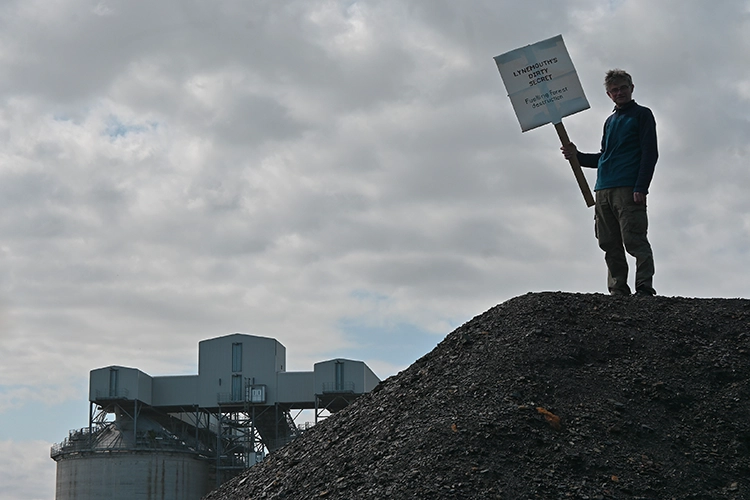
[594,187,656,295]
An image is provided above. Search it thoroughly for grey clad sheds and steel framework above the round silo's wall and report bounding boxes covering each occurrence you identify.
[50,334,379,494]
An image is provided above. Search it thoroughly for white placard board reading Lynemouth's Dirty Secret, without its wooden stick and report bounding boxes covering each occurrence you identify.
[495,35,589,132]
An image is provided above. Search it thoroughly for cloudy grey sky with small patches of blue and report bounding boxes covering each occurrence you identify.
[0,0,750,500]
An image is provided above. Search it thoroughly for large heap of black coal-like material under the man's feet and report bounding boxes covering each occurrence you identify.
[206,292,750,500]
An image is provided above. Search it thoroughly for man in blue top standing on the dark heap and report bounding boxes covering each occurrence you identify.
[561,69,659,296]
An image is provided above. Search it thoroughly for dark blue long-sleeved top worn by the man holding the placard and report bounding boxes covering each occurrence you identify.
[578,101,659,194]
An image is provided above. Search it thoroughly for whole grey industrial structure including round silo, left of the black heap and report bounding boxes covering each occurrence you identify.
[50,333,380,500]
